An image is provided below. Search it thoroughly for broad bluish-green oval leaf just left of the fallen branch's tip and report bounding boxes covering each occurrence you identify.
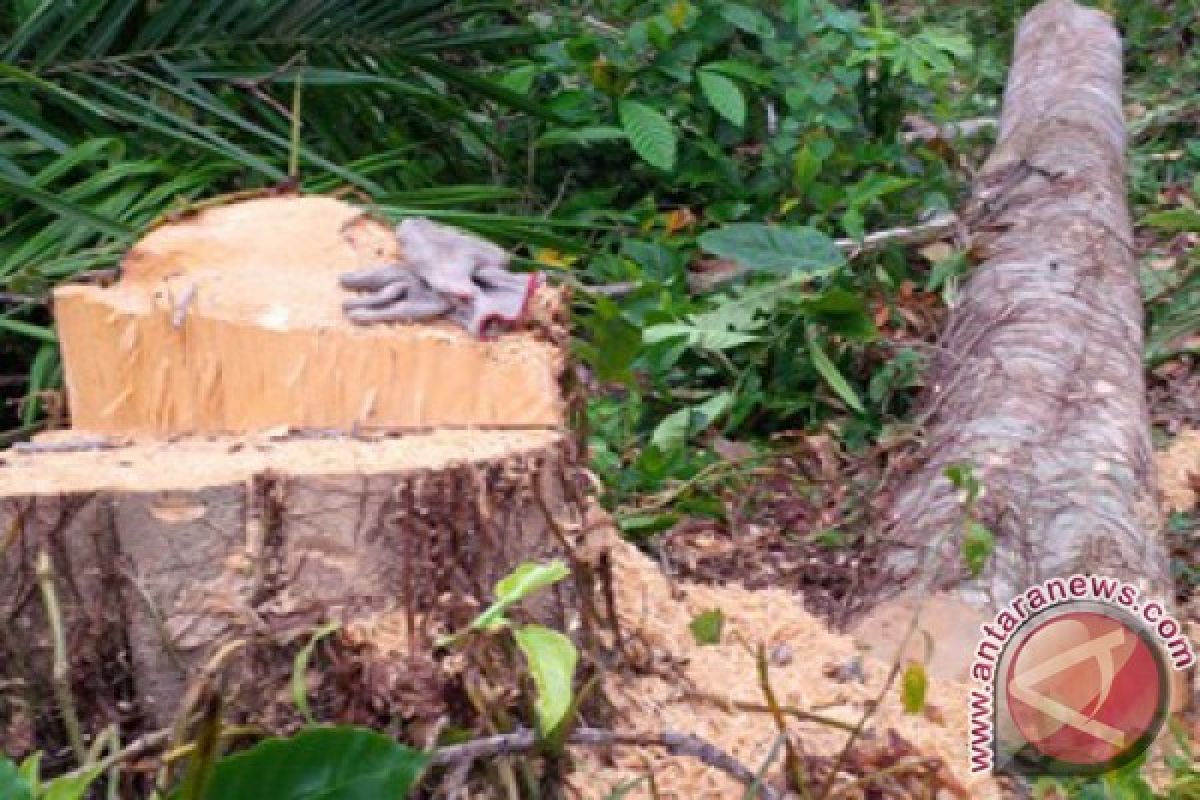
[697,222,846,273]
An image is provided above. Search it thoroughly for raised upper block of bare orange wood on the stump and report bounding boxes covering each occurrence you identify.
[54,197,564,435]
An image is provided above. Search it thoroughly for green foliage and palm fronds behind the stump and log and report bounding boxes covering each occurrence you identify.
[0,0,1200,522]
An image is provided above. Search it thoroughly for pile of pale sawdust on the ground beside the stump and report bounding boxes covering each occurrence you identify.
[570,533,1000,800]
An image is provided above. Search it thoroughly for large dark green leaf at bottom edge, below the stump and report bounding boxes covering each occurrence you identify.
[204,726,430,800]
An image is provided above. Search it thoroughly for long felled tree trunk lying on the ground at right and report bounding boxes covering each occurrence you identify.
[868,0,1171,666]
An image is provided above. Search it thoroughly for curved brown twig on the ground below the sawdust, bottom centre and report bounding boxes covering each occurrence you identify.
[432,728,781,800]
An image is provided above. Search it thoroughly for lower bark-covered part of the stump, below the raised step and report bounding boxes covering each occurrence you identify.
[0,431,586,746]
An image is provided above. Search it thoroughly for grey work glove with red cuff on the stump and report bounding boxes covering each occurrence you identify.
[341,217,541,337]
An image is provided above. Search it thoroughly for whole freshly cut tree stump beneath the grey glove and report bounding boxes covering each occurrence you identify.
[0,197,586,754]
